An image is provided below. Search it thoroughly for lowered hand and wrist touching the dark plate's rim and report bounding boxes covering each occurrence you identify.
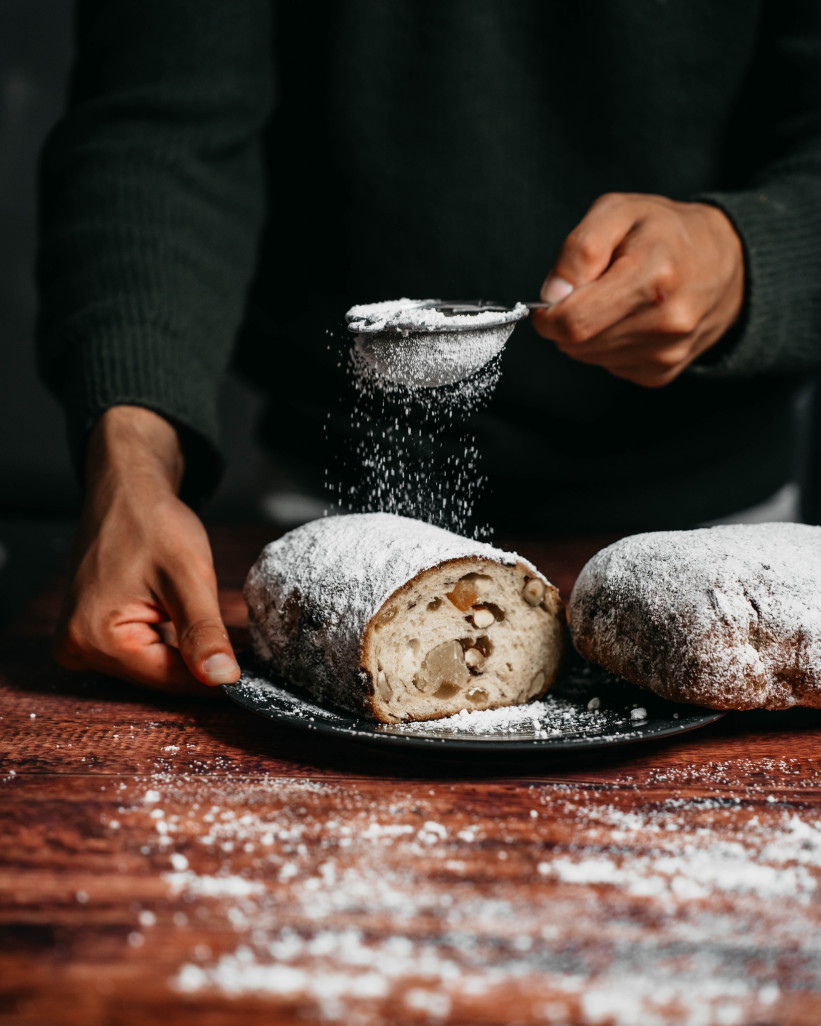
[54,406,239,694]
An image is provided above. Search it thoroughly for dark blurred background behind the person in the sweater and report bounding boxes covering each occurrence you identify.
[0,0,821,624]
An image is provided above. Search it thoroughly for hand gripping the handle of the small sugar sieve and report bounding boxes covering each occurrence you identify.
[533,193,744,388]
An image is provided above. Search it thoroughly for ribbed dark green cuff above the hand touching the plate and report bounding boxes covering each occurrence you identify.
[62,323,224,505]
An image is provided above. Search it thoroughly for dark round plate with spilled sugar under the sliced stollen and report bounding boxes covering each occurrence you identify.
[223,655,724,754]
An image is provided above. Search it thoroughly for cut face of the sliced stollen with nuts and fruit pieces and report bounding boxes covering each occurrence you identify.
[363,558,561,720]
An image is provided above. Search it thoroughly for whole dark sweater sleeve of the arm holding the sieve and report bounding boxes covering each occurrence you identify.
[693,0,821,376]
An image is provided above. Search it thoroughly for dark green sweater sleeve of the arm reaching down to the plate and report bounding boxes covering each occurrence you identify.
[37,0,273,499]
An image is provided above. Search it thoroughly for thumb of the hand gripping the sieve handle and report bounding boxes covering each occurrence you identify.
[540,194,637,304]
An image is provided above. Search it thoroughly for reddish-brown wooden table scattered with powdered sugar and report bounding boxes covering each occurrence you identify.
[0,529,821,1026]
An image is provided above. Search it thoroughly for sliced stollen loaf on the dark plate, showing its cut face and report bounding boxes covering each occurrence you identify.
[245,513,565,722]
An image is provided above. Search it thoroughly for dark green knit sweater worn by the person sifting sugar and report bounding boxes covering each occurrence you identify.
[38,0,821,529]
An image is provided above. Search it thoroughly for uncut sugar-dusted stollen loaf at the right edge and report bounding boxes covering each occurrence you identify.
[570,523,821,709]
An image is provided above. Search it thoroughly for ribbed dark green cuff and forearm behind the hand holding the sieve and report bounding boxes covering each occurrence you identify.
[693,174,821,374]
